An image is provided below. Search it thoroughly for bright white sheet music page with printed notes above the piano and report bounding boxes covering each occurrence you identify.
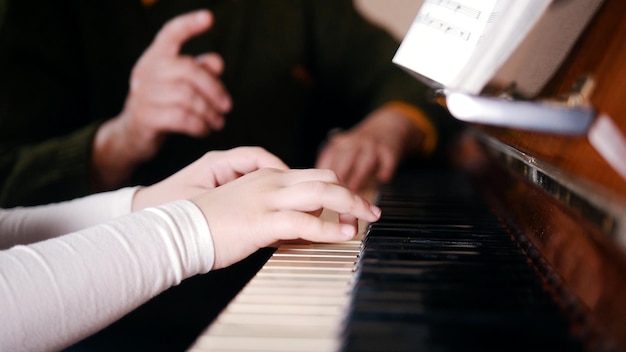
[393,0,550,94]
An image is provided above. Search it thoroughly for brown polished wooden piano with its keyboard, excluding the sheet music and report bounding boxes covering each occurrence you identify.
[189,0,626,352]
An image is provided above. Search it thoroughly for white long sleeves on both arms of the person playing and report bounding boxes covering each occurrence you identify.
[0,188,214,351]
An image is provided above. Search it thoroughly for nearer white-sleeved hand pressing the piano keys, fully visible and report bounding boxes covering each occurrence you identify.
[192,168,380,269]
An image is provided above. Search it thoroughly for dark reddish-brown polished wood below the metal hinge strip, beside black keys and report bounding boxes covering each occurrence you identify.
[457,136,626,351]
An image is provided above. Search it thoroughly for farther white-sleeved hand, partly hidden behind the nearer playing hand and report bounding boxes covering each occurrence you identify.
[133,147,287,211]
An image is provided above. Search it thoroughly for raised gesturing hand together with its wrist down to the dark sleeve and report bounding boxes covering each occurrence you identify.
[93,10,232,189]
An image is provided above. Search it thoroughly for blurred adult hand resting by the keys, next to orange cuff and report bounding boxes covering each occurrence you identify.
[315,108,424,191]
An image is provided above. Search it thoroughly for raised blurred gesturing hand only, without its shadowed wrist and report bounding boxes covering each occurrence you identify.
[122,11,231,148]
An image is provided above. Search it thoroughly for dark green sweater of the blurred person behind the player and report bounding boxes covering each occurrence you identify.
[0,0,450,207]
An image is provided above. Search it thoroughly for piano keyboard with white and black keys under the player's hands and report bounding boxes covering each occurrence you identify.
[190,171,584,352]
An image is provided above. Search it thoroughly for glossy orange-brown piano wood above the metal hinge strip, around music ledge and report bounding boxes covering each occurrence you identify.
[472,0,626,198]
